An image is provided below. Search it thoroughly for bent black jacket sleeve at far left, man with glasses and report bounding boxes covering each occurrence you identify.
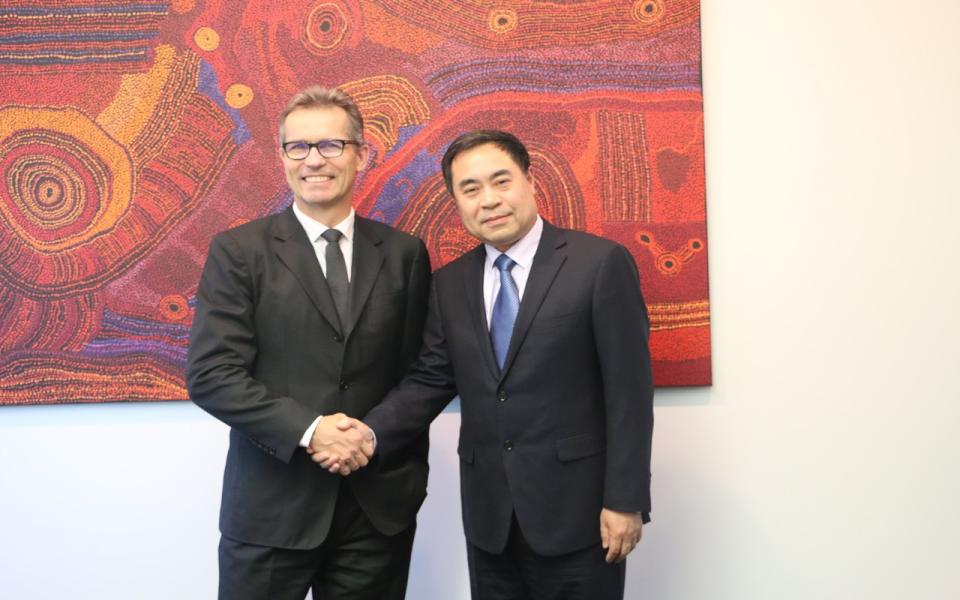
[186,232,317,462]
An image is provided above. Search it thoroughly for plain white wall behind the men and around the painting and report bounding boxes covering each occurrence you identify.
[0,0,960,600]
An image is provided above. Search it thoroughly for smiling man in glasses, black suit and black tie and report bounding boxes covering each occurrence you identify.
[187,87,430,600]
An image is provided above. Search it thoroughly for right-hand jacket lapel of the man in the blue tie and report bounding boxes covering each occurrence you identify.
[491,220,567,377]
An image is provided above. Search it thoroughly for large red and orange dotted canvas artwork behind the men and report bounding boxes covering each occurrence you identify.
[0,0,710,404]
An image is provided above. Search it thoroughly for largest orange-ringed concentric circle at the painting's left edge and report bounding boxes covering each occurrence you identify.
[0,106,134,252]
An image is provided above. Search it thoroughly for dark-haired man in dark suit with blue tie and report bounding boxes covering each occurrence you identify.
[314,131,653,600]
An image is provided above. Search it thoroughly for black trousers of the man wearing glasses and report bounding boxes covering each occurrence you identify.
[219,484,416,600]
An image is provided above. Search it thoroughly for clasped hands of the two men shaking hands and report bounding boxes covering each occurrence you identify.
[307,413,374,475]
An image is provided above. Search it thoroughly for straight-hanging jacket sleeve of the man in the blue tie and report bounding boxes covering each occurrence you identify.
[593,245,653,520]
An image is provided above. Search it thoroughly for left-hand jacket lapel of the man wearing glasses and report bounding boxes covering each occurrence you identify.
[273,208,343,333]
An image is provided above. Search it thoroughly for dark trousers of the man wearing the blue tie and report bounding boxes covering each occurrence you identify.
[467,518,626,600]
